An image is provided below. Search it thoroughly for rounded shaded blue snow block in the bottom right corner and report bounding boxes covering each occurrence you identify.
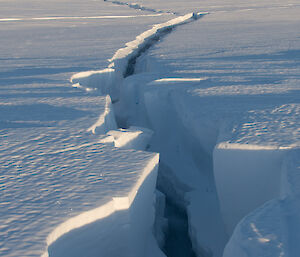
[223,149,300,257]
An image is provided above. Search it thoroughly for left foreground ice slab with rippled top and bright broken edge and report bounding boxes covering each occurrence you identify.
[0,124,158,256]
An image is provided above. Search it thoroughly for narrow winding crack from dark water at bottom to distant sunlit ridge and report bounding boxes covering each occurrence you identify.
[71,2,211,254]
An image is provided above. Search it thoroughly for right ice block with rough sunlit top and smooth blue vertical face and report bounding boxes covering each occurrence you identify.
[214,104,300,235]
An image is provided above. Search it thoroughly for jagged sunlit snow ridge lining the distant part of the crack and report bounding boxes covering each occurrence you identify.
[70,12,207,91]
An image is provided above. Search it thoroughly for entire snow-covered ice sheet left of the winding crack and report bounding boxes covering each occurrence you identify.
[0,0,168,256]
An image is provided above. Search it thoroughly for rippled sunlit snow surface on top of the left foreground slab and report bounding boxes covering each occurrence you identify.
[1,129,158,256]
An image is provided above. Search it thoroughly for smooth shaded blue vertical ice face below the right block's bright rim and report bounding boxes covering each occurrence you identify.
[213,143,284,235]
